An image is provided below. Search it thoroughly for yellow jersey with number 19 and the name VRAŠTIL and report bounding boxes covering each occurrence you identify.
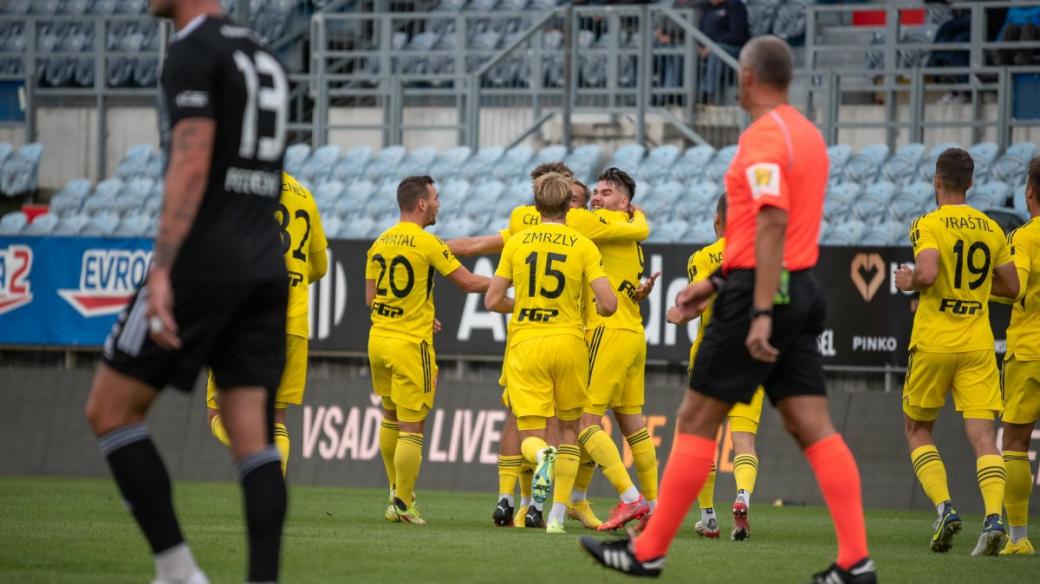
[910,205,1011,352]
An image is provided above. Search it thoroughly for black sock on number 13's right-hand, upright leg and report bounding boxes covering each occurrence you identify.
[236,446,286,582]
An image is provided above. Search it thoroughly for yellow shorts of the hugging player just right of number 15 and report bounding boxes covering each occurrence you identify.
[584,326,647,416]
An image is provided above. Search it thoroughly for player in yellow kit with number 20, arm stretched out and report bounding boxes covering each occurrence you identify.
[365,177,491,525]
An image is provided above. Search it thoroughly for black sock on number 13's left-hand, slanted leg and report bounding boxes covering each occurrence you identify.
[98,424,184,554]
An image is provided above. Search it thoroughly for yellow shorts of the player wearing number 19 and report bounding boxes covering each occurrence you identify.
[903,350,1004,422]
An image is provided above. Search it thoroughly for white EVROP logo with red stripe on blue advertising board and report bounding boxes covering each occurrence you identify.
[58,249,152,318]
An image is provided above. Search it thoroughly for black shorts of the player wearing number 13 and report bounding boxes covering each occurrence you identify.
[103,278,289,392]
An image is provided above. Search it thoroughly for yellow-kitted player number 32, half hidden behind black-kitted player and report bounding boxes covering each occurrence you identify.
[206,172,329,475]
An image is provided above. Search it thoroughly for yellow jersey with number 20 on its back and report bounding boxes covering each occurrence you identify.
[365,221,462,343]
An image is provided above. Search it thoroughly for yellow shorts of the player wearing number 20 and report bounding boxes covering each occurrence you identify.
[368,337,437,422]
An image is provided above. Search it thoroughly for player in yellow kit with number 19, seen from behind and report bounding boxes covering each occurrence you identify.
[895,148,1019,556]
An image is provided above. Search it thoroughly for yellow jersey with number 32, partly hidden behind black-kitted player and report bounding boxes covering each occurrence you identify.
[275,174,329,339]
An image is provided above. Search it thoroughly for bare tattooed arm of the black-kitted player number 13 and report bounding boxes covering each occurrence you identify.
[148,117,216,350]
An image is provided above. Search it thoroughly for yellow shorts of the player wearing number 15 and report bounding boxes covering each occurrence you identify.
[505,335,589,422]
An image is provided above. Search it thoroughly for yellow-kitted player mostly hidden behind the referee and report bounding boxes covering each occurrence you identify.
[669,193,765,541]
